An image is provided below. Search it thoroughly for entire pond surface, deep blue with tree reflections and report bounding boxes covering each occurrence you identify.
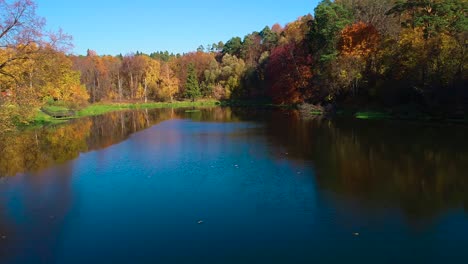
[0,108,468,264]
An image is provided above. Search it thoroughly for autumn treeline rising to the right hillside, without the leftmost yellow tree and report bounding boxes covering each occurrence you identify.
[68,0,468,107]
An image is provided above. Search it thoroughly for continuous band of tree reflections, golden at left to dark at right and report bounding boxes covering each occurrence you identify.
[0,108,468,223]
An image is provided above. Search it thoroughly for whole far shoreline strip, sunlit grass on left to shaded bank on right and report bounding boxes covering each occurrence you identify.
[25,100,468,127]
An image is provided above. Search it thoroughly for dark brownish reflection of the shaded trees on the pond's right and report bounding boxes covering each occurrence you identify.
[256,113,468,221]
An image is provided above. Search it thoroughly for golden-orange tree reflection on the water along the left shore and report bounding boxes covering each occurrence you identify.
[0,108,236,178]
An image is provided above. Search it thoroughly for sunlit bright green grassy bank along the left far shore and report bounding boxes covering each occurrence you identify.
[30,100,220,127]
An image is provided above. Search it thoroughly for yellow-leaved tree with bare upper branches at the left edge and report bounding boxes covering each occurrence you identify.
[0,0,76,132]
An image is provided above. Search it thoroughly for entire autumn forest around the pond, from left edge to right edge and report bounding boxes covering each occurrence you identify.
[0,0,468,130]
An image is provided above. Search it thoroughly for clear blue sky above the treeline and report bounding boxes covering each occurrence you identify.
[36,0,319,55]
